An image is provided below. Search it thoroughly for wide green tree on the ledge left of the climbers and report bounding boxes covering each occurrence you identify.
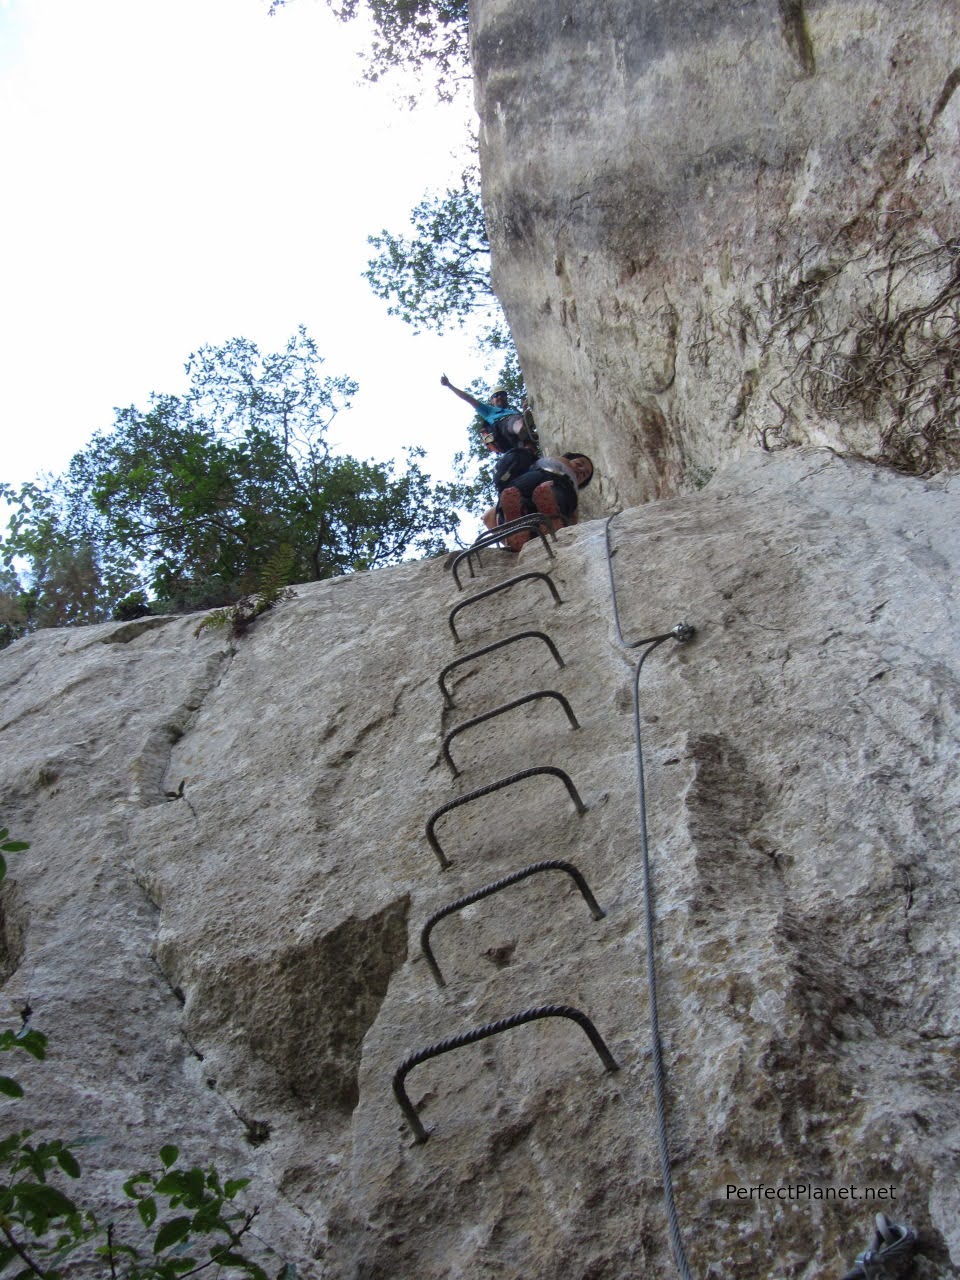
[0,328,465,627]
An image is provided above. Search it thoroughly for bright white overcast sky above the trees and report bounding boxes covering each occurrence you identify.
[0,0,483,494]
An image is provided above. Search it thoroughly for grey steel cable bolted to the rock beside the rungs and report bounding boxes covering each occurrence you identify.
[604,516,694,1280]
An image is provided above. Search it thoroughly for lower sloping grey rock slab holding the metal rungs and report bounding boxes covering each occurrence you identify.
[0,449,960,1280]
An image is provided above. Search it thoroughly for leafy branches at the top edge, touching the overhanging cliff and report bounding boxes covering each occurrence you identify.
[269,0,470,101]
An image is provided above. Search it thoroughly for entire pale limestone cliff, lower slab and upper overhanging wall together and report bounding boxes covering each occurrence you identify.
[0,0,960,1280]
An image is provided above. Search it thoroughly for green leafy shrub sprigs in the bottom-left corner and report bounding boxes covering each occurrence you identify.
[0,827,285,1280]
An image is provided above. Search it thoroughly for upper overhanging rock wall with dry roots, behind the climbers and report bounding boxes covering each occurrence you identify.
[471,0,960,512]
